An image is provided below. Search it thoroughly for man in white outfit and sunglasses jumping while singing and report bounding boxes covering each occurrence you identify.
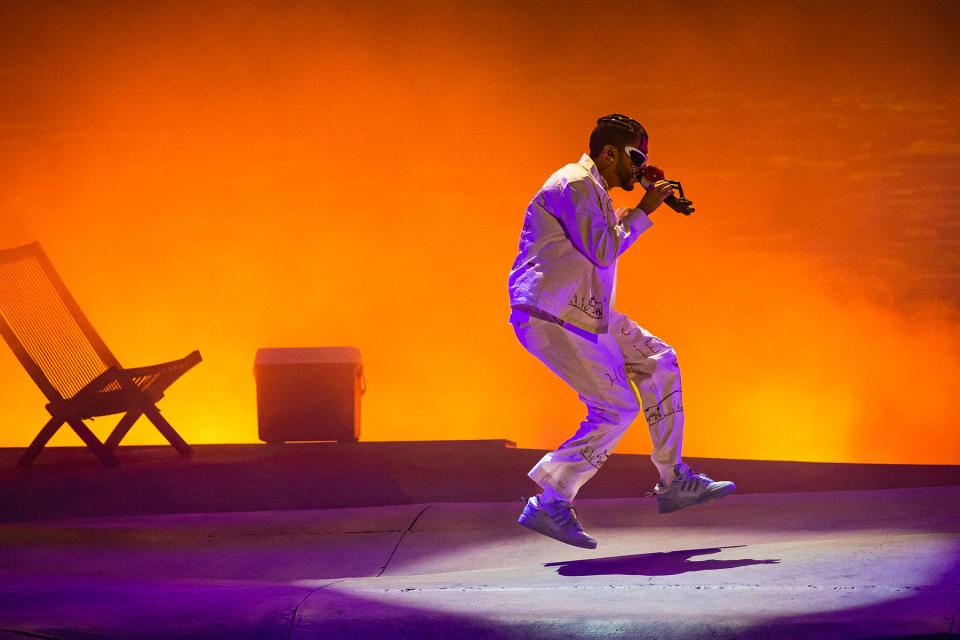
[509,114,735,549]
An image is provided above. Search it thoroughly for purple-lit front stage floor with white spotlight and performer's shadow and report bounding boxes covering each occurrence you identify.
[0,486,960,640]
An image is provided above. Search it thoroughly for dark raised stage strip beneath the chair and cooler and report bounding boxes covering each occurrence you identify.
[0,440,960,522]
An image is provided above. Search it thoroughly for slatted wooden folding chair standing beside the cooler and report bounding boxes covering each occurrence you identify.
[0,242,201,467]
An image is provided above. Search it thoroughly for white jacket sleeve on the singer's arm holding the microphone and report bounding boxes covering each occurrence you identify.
[554,180,653,267]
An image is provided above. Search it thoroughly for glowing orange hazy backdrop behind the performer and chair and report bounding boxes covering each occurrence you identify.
[0,0,960,464]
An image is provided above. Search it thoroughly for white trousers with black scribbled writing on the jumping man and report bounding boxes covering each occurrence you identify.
[510,311,683,500]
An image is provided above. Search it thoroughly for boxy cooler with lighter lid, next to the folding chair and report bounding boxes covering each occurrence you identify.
[253,347,365,443]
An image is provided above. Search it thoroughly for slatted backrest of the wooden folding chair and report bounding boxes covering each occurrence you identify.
[0,242,119,401]
